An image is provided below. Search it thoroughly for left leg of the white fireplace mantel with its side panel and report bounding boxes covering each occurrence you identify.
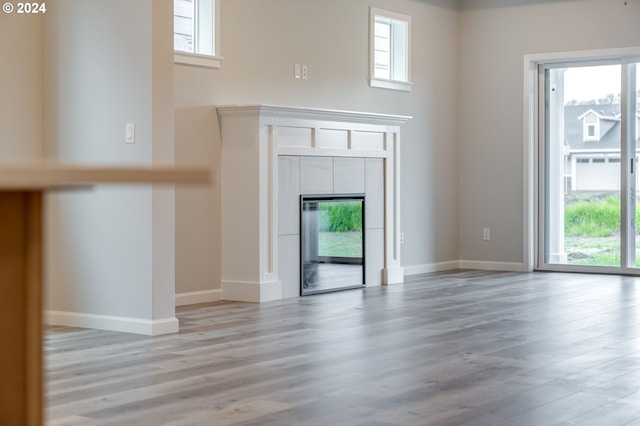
[218,107,282,302]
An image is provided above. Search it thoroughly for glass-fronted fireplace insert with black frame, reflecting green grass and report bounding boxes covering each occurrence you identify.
[300,194,366,296]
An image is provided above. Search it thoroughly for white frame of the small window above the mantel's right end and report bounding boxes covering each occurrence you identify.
[369,7,413,92]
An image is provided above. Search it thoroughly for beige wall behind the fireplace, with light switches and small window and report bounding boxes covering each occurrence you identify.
[174,0,458,293]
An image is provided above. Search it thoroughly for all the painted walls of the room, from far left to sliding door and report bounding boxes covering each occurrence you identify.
[11,0,624,320]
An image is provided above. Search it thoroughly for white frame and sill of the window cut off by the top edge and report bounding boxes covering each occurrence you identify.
[173,0,222,69]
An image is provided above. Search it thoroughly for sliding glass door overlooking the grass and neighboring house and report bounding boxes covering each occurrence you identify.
[538,59,640,272]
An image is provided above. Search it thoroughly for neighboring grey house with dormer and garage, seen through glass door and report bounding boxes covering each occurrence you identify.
[564,104,640,191]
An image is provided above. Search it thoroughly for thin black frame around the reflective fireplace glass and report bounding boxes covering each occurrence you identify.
[299,193,366,296]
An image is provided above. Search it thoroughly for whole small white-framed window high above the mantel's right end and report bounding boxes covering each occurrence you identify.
[369,7,411,91]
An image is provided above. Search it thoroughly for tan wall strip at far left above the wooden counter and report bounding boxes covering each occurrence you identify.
[0,13,42,161]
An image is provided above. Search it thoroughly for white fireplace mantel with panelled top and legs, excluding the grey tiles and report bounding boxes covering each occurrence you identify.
[217,105,411,302]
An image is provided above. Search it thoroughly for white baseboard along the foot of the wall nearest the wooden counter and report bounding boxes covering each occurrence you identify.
[44,311,178,336]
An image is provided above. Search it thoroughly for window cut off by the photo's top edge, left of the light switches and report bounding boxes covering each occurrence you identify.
[173,0,221,68]
